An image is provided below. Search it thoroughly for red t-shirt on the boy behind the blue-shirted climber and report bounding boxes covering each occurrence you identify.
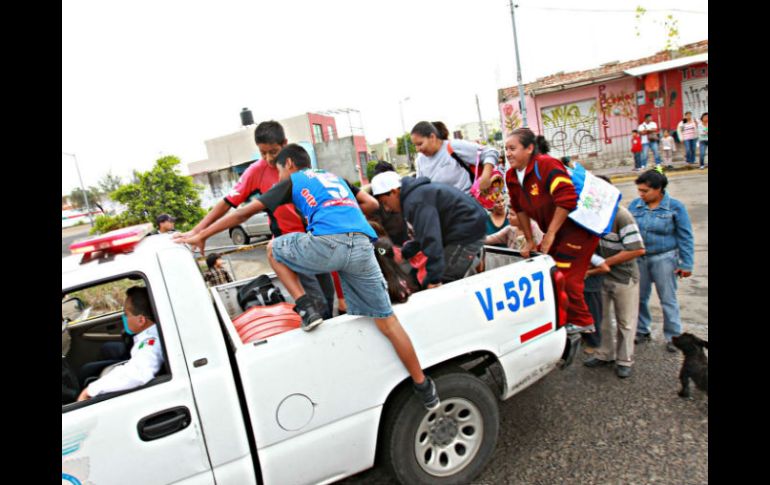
[225,160,305,237]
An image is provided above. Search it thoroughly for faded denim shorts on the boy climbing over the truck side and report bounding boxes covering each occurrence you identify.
[273,232,393,318]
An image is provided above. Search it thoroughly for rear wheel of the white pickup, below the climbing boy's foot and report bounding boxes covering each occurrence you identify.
[382,368,500,485]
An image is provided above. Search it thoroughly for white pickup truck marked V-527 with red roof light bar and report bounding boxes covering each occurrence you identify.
[62,227,578,485]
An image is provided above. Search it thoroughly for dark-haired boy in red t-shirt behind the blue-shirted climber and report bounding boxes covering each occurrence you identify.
[174,121,334,318]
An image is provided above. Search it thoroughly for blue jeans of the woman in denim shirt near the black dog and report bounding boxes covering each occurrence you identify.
[636,250,682,342]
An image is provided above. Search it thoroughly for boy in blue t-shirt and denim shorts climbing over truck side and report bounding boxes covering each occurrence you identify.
[180,144,440,410]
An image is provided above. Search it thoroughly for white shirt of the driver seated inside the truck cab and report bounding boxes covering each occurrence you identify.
[88,325,163,397]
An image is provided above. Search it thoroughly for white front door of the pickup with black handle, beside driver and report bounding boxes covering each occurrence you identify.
[62,274,214,485]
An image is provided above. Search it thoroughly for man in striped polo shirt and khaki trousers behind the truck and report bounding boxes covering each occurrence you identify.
[584,187,645,378]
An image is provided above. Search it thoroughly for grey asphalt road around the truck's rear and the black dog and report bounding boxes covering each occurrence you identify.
[341,173,708,485]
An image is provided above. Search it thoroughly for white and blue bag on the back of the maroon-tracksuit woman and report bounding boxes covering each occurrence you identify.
[535,161,622,237]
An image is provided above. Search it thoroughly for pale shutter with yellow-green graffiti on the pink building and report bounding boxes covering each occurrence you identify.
[540,99,601,157]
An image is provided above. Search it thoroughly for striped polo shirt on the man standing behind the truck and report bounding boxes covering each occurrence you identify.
[599,206,644,284]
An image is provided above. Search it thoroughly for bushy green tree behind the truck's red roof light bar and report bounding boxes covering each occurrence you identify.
[92,155,206,232]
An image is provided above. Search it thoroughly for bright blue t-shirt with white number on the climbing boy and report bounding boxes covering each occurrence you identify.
[260,168,377,241]
